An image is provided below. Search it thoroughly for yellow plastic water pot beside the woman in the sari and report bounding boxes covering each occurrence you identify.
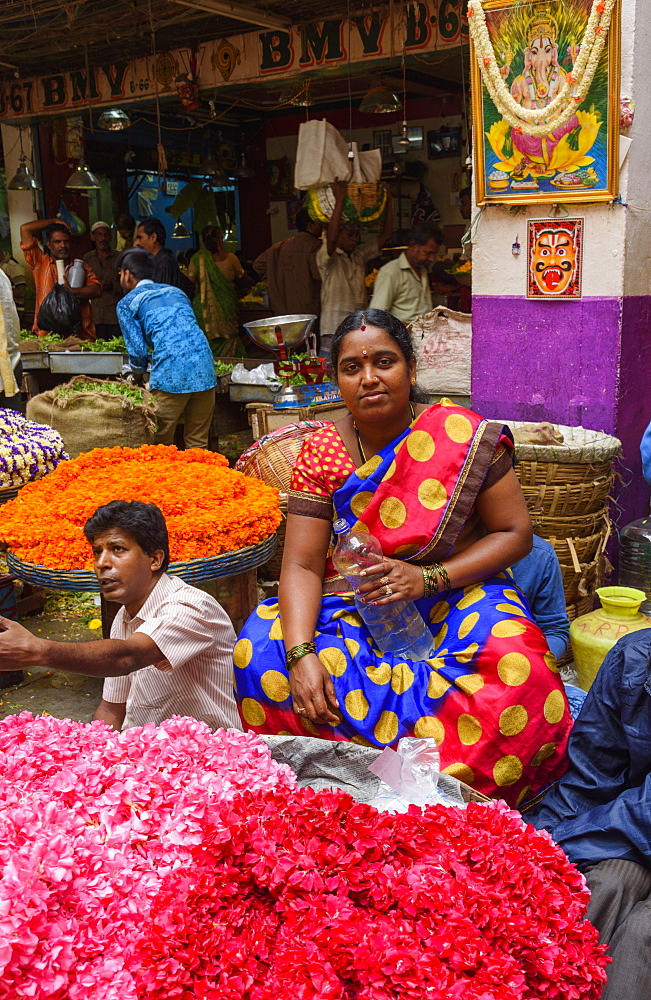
[570,587,651,691]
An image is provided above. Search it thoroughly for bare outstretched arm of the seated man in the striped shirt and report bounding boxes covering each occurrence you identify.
[0,617,165,677]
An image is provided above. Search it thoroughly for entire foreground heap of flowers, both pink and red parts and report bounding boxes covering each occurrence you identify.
[0,713,608,1000]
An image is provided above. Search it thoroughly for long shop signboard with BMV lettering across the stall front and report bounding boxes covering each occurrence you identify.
[0,0,468,124]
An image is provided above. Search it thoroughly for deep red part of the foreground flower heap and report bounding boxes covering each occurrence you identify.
[134,789,609,1000]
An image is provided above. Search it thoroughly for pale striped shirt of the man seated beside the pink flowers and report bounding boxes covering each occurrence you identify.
[103,574,242,729]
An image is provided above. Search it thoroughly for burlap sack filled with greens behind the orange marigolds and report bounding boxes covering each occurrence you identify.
[27,375,156,458]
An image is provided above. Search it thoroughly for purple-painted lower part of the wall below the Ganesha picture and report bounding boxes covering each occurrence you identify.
[472,295,651,540]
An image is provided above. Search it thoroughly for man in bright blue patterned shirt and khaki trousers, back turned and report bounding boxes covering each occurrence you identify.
[116,247,216,448]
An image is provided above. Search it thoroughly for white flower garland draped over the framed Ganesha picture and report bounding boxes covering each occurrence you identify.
[468,0,617,137]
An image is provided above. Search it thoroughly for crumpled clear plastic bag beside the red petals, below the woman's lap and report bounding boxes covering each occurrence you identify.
[369,736,467,812]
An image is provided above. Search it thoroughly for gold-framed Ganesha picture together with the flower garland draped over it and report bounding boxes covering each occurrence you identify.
[468,0,620,205]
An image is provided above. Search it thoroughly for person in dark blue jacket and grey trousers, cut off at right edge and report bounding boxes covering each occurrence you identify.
[525,629,651,1000]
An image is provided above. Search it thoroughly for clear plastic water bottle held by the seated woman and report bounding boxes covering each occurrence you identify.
[332,518,435,662]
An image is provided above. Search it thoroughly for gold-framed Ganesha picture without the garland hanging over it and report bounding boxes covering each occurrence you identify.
[470,0,621,206]
